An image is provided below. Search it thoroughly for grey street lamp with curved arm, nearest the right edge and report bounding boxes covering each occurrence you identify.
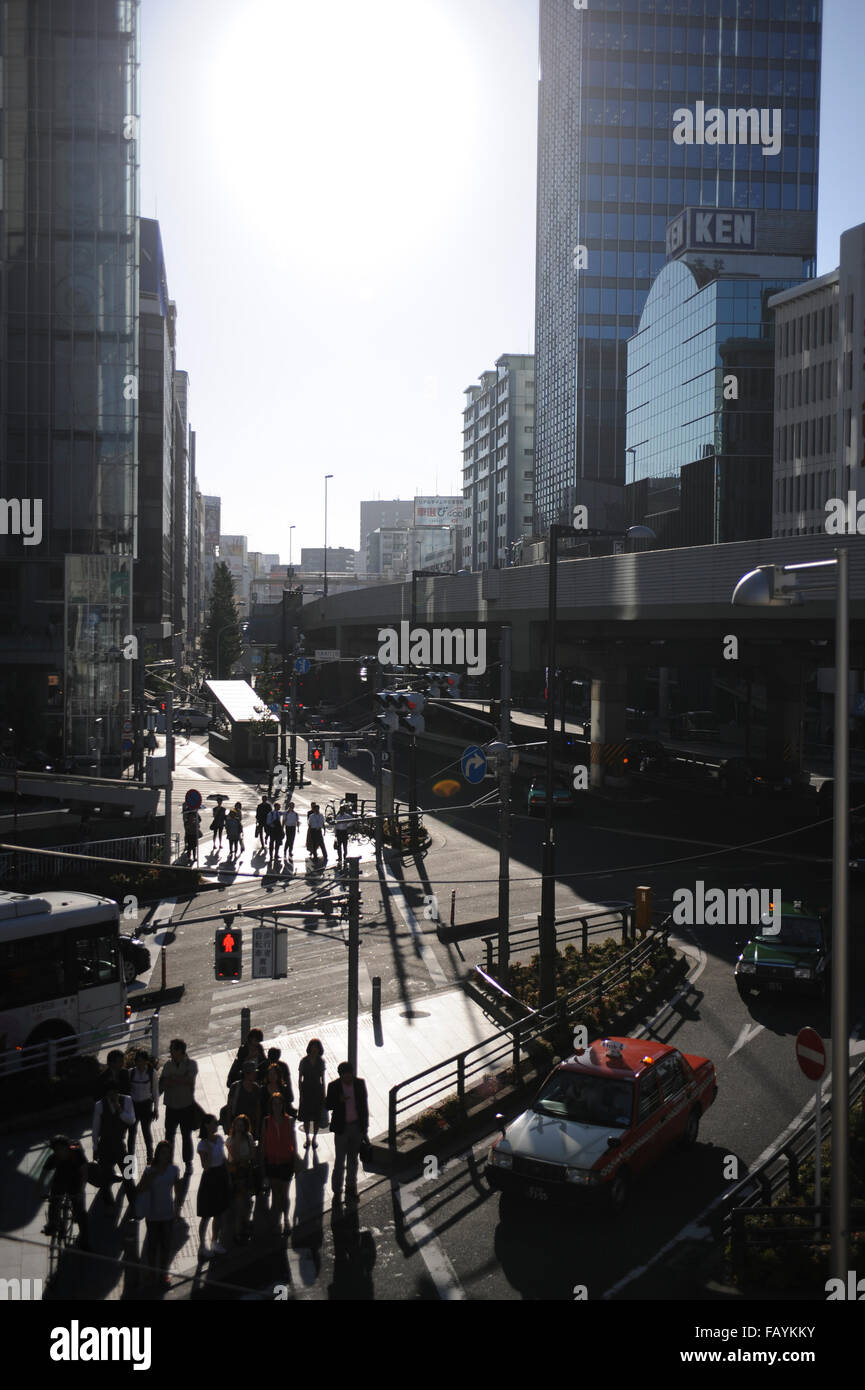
[733,546,850,1280]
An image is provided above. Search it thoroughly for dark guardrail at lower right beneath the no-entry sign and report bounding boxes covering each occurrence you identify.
[722,1058,865,1279]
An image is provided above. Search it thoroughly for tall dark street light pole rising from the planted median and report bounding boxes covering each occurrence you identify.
[538,525,655,1008]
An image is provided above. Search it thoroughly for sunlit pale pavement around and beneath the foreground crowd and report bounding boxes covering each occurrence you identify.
[0,988,495,1300]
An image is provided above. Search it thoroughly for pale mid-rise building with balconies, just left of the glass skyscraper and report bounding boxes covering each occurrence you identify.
[462,353,534,570]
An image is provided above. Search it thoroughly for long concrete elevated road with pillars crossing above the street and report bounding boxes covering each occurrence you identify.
[294,535,865,784]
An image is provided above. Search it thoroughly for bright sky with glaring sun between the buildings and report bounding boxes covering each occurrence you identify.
[139,0,865,563]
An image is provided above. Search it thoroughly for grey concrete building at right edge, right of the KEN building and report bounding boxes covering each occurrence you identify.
[770,224,865,535]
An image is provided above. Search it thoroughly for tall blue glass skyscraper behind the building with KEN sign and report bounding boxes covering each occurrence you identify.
[535,0,822,530]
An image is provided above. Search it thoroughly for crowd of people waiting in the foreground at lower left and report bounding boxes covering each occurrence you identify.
[45,1029,370,1286]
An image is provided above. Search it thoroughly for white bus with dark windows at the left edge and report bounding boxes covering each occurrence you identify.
[0,890,127,1054]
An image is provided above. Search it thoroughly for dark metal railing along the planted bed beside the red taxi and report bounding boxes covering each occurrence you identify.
[388,919,670,1148]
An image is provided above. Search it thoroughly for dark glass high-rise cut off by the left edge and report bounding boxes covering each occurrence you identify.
[0,0,139,766]
